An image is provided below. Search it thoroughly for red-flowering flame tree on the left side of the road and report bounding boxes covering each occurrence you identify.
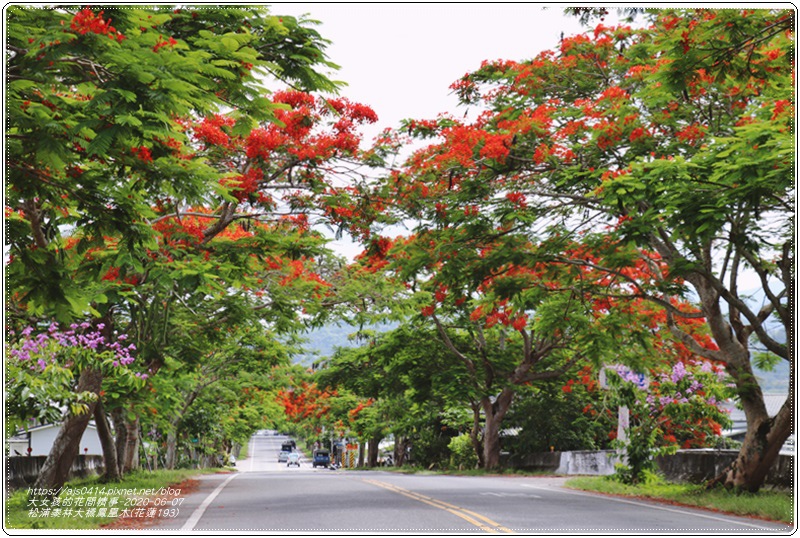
[5,6,375,488]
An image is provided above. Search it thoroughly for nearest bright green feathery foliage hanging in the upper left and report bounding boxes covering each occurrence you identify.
[6,6,338,321]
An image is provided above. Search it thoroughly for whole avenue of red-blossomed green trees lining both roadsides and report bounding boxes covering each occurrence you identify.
[4,6,795,491]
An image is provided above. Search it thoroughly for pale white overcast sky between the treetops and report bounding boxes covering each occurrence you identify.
[269,2,585,142]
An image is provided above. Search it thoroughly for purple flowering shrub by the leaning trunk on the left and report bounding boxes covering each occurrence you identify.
[5,323,147,428]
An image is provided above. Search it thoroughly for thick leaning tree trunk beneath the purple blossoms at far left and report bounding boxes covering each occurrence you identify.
[33,368,103,490]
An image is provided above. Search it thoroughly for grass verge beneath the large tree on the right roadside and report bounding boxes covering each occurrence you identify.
[565,477,794,525]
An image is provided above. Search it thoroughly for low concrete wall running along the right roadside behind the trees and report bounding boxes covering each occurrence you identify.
[501,450,794,488]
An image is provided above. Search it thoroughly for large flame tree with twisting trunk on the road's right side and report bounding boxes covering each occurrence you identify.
[362,9,794,484]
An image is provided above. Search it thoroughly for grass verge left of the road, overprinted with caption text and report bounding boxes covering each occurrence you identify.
[5,469,219,530]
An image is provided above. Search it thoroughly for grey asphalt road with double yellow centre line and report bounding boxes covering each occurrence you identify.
[154,436,793,535]
